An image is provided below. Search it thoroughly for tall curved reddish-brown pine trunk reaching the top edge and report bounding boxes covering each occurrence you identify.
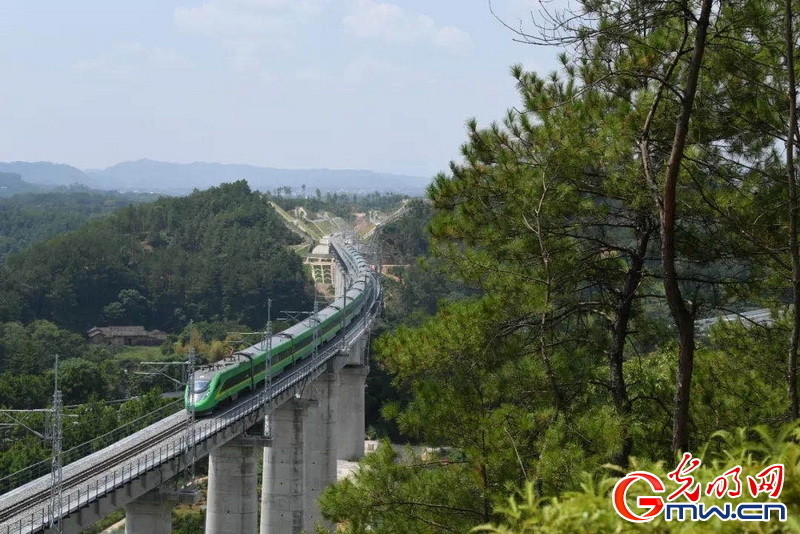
[661,0,713,453]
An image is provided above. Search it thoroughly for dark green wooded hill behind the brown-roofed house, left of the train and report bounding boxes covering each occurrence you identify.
[0,181,309,331]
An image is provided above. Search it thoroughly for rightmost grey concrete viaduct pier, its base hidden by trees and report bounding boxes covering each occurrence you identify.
[335,365,369,460]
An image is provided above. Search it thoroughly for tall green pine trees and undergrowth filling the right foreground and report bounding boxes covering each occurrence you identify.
[322,0,800,534]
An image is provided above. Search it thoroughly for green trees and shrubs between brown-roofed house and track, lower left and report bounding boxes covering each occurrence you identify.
[0,314,187,486]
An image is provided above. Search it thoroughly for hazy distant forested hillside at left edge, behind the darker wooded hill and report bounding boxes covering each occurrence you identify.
[0,191,157,263]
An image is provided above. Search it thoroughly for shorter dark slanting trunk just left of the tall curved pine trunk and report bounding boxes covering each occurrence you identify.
[608,220,653,467]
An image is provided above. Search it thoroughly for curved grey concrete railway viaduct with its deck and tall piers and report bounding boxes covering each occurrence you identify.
[0,237,380,534]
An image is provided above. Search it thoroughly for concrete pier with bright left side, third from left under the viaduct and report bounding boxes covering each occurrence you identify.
[261,399,314,534]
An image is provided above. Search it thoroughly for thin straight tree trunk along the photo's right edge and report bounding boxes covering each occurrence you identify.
[785,0,800,419]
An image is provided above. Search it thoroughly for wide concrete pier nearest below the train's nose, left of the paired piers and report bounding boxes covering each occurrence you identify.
[206,438,258,534]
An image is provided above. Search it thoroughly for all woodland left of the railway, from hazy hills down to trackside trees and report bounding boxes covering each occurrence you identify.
[0,182,318,493]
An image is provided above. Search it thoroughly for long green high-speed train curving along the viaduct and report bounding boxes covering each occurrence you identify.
[184,240,374,414]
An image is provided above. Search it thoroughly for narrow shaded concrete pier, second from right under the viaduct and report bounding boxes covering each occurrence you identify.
[303,371,339,532]
